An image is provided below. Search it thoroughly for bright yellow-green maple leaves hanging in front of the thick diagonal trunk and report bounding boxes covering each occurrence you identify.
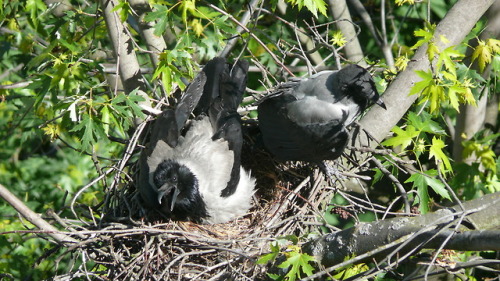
[382,15,498,213]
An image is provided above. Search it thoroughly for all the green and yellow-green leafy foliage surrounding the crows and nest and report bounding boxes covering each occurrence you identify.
[0,0,500,280]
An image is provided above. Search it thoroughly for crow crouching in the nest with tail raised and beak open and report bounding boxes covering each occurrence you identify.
[138,58,255,223]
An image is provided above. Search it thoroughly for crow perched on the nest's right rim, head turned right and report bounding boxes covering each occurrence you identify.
[258,65,385,165]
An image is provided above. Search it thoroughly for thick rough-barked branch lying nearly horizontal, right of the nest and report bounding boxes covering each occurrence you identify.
[303,192,500,267]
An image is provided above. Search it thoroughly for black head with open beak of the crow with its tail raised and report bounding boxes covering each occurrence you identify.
[153,160,209,222]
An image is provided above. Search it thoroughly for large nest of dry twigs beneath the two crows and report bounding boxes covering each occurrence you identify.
[41,117,386,280]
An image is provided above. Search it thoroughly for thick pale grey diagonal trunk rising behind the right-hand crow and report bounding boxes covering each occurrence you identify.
[355,0,495,147]
